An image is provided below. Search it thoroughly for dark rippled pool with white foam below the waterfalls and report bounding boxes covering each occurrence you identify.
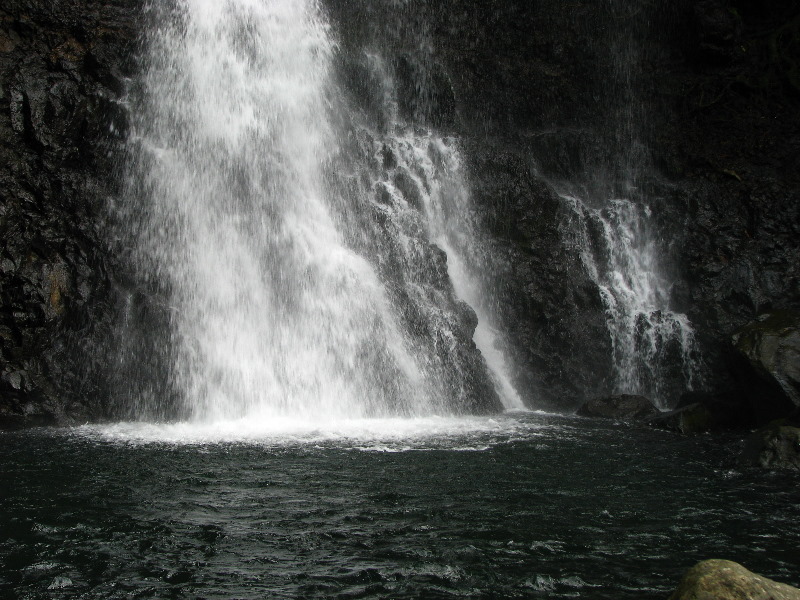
[0,414,800,599]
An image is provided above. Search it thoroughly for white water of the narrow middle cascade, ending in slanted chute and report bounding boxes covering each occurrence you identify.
[344,49,525,410]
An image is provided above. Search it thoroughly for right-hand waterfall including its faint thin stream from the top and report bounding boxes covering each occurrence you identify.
[554,0,700,408]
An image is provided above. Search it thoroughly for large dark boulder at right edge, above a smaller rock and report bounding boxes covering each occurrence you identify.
[733,310,800,416]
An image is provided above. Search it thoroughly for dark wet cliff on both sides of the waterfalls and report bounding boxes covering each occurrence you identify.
[0,0,800,425]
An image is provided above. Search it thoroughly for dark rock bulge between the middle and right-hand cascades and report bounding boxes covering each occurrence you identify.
[466,139,612,410]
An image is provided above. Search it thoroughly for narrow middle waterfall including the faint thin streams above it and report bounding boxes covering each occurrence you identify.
[330,25,525,410]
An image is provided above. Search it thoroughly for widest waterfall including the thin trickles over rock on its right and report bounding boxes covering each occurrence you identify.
[119,0,521,421]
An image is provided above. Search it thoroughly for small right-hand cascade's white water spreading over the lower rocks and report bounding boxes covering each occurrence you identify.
[562,195,697,408]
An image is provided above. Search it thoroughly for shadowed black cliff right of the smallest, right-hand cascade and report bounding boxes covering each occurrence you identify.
[660,0,800,408]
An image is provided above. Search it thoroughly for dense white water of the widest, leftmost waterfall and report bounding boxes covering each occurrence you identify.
[126,0,456,420]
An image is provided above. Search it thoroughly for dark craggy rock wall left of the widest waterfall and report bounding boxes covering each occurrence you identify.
[0,0,137,427]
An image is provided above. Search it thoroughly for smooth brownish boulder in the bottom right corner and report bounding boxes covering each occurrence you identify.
[670,560,800,600]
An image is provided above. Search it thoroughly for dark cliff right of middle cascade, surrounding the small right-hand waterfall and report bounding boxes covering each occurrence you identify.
[418,0,800,412]
